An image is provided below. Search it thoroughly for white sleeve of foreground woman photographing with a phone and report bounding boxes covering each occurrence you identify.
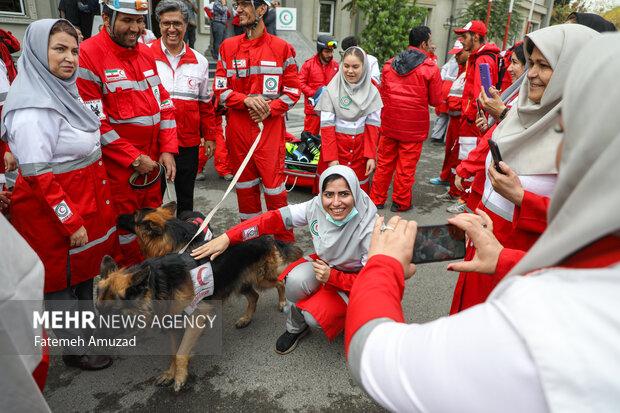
[356,303,547,413]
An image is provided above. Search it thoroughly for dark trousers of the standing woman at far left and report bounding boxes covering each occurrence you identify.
[44,278,95,356]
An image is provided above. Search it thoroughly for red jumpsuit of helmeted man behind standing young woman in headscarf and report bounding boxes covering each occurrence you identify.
[299,54,338,135]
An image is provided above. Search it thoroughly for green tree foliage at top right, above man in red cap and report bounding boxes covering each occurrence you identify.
[458,0,523,47]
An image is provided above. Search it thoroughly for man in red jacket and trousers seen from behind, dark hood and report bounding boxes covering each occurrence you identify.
[370,26,442,212]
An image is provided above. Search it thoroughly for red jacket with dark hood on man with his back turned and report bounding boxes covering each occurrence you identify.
[379,46,442,142]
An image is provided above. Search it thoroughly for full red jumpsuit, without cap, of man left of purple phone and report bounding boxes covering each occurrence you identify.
[459,43,499,204]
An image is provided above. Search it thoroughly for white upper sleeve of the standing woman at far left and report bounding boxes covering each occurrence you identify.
[5,108,61,172]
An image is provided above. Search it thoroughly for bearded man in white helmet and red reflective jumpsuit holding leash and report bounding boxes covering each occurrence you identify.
[77,0,178,265]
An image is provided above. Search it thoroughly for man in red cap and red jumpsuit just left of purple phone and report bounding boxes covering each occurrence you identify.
[448,20,499,213]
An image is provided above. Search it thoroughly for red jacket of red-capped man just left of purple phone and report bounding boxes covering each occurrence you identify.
[461,43,499,126]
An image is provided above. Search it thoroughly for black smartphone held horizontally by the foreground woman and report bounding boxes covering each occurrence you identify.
[411,224,465,264]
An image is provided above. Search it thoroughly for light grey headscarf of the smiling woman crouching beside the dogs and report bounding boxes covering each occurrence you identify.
[306,165,377,272]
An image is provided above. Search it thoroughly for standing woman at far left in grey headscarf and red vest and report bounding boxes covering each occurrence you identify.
[2,19,120,370]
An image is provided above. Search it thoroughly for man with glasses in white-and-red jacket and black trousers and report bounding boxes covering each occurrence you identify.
[149,0,222,213]
